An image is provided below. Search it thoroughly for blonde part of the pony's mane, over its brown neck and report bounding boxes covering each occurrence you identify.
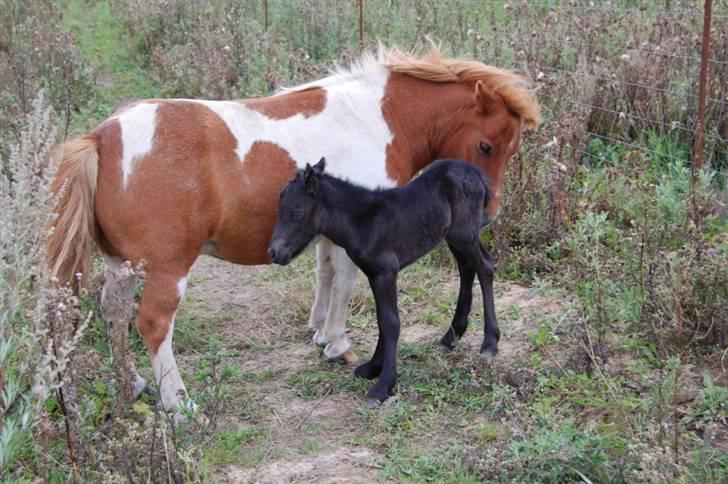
[379,43,541,128]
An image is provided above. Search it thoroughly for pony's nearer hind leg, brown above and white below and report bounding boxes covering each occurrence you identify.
[137,272,194,410]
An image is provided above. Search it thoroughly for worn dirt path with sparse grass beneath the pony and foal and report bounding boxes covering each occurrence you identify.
[178,255,558,482]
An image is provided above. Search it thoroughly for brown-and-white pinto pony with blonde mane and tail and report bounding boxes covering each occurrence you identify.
[48,47,540,408]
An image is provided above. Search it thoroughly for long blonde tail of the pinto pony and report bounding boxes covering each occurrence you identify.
[47,136,99,289]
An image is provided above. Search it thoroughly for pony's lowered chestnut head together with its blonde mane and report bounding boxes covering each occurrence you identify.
[384,44,541,217]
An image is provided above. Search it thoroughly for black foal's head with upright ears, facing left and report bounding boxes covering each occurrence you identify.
[268,158,326,265]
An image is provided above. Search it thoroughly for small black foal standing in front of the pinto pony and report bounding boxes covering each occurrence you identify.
[268,158,500,405]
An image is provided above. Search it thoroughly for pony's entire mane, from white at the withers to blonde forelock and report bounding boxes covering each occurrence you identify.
[282,43,541,128]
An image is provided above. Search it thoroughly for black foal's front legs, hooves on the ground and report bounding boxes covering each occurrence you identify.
[355,273,399,407]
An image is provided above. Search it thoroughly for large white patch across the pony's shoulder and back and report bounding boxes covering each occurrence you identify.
[189,59,396,189]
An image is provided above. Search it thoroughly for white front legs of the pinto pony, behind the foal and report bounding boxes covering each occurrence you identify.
[314,244,358,360]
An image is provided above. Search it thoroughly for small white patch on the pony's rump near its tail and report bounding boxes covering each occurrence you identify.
[117,103,157,188]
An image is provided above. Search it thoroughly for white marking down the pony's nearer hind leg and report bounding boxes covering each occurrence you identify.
[152,277,187,410]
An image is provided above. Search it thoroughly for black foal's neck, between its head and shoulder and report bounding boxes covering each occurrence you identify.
[317,176,378,248]
